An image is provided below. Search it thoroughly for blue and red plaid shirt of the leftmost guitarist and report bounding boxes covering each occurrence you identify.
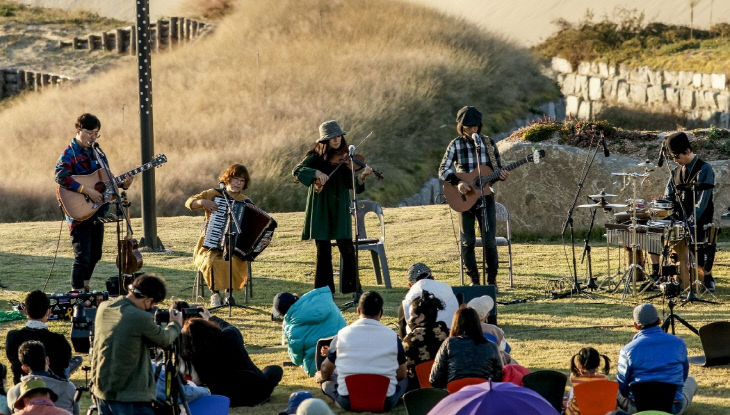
[56,138,108,230]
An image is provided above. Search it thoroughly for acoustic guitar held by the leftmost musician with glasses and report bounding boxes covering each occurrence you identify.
[56,154,167,220]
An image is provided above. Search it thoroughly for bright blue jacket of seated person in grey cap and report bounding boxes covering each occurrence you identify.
[616,326,689,400]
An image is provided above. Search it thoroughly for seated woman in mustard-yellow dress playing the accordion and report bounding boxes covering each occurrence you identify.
[185,164,250,307]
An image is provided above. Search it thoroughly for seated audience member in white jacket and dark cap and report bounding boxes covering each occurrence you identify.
[398,262,459,339]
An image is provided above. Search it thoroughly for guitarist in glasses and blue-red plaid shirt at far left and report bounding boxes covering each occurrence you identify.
[56,114,134,291]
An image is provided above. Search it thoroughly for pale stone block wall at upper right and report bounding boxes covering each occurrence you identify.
[550,57,730,128]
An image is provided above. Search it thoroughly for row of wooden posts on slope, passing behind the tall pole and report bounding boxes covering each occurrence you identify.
[59,17,213,55]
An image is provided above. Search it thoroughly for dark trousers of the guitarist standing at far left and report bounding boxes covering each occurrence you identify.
[71,216,104,290]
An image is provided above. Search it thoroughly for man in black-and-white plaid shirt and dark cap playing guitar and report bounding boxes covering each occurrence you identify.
[439,106,509,285]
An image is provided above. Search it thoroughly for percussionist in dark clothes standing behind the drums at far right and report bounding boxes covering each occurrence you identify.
[664,132,716,291]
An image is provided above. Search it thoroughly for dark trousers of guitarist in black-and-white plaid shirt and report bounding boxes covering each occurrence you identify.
[460,195,499,284]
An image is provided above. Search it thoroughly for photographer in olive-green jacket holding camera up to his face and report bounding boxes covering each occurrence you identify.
[91,274,182,415]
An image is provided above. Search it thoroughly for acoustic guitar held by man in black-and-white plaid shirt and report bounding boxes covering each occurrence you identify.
[443,150,545,212]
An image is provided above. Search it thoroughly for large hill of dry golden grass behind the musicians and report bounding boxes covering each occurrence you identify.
[0,0,558,221]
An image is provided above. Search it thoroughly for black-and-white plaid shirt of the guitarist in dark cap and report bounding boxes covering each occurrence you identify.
[439,135,502,185]
